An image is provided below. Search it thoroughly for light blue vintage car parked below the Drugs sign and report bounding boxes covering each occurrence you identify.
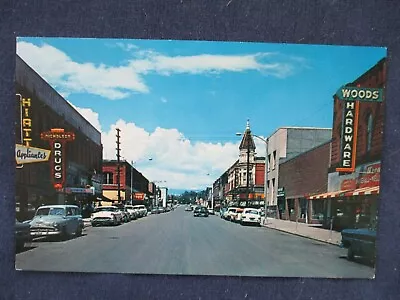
[30,205,83,240]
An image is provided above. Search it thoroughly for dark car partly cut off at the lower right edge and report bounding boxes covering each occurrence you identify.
[340,221,377,262]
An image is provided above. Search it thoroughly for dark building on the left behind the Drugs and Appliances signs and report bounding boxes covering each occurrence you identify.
[15,55,103,219]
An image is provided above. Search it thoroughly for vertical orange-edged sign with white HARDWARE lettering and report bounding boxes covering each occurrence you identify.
[336,101,360,172]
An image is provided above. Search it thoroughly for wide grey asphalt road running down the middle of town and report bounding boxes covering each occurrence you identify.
[16,206,374,278]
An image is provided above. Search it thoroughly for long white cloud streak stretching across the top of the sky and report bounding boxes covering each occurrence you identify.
[17,40,304,100]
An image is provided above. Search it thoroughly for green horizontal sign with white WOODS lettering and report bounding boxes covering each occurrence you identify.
[336,86,383,102]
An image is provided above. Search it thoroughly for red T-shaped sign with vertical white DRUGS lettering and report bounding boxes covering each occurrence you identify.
[40,128,75,189]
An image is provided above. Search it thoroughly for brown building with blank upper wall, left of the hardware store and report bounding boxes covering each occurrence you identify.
[278,141,330,223]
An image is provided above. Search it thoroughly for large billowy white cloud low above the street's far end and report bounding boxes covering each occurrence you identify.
[93,115,239,189]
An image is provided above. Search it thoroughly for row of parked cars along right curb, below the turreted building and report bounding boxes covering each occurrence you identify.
[220,207,264,226]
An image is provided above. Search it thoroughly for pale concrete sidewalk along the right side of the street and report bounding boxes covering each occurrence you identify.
[261,218,341,245]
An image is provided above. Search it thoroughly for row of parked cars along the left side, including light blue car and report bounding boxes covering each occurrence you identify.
[15,205,148,251]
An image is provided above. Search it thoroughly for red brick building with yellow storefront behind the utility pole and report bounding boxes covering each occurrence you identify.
[102,160,156,206]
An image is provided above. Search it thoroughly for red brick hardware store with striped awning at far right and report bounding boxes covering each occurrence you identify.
[309,58,386,230]
